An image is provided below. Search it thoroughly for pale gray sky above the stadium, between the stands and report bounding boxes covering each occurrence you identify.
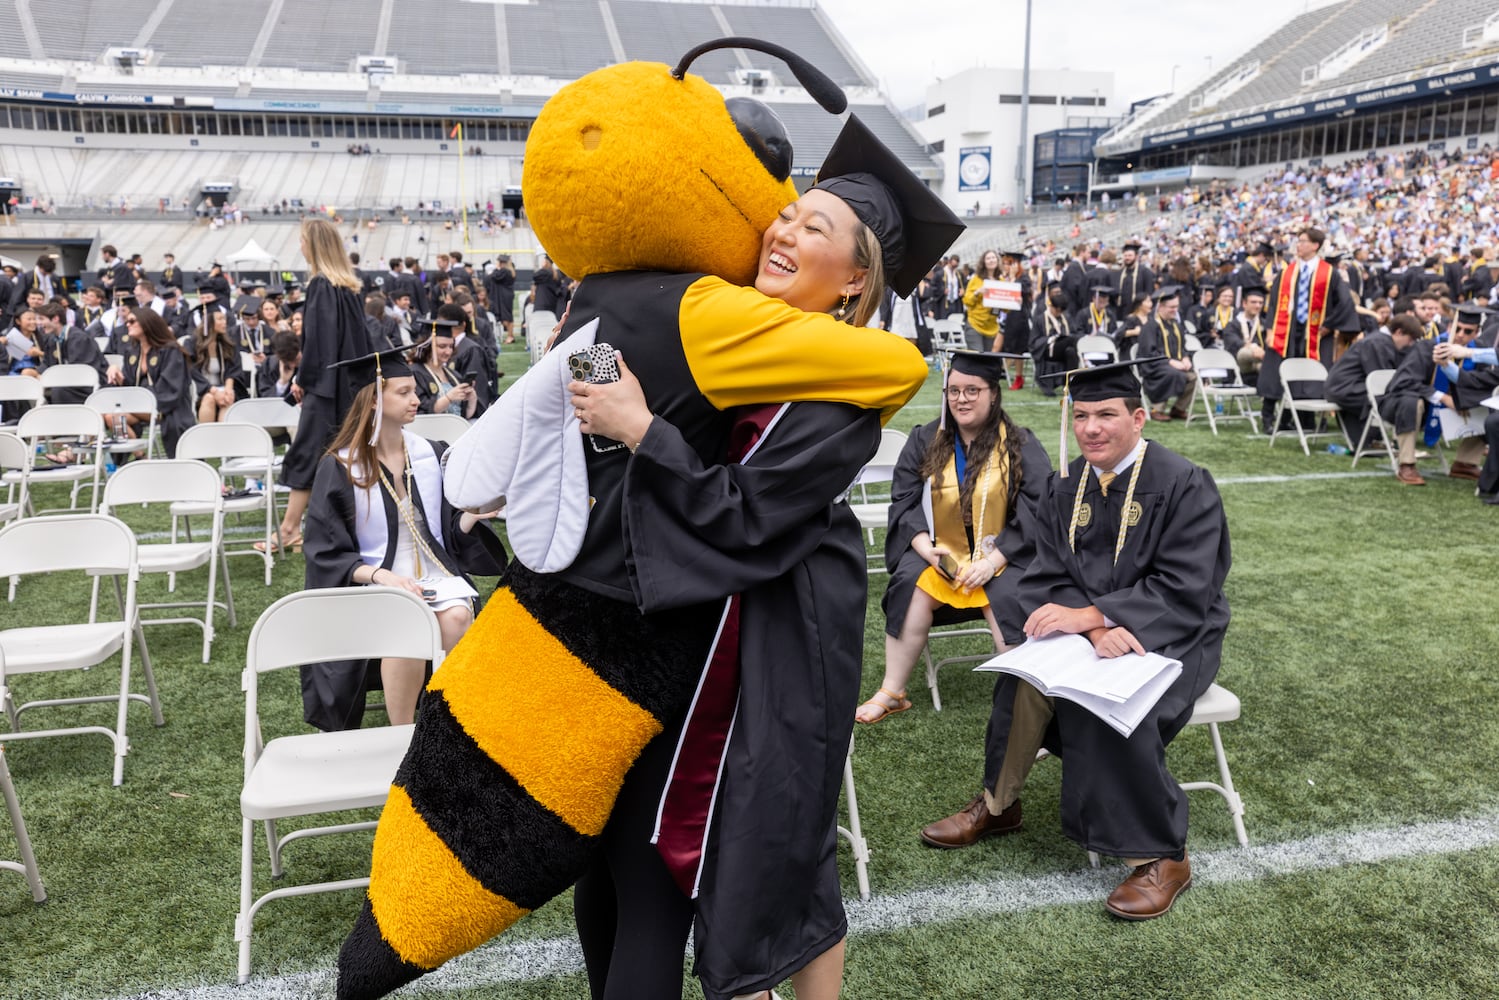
[818,0,1336,108]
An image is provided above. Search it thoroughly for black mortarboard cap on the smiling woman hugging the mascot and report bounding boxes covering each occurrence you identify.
[814,114,967,298]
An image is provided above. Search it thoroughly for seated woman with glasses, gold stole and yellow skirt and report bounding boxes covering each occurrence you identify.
[854,351,1051,723]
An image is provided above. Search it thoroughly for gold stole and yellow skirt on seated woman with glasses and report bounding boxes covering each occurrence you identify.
[916,427,1010,607]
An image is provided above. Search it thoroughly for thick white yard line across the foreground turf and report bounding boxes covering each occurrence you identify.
[110,814,1499,1000]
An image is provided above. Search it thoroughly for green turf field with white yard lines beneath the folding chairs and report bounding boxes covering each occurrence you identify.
[0,340,1499,1000]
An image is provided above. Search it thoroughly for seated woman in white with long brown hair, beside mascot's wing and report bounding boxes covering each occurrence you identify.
[301,348,507,732]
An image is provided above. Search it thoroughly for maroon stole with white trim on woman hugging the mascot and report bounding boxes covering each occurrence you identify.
[652,405,784,898]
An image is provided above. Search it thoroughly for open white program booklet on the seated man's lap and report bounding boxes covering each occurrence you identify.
[974,636,1181,739]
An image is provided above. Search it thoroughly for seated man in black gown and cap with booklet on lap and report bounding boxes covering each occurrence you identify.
[922,361,1231,921]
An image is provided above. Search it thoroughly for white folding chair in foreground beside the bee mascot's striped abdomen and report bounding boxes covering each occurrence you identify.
[234,586,442,985]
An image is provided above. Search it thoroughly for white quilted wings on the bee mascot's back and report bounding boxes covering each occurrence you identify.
[442,319,598,573]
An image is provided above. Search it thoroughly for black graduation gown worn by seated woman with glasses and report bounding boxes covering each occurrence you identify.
[880,420,1051,645]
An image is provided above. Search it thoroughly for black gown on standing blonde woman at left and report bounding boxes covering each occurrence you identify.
[279,274,372,489]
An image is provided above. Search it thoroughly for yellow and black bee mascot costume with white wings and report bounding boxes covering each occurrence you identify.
[337,39,926,1000]
